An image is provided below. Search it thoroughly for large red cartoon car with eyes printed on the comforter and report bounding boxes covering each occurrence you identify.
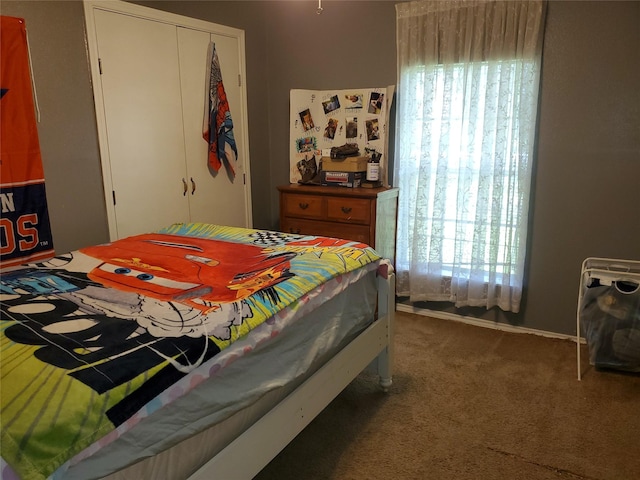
[80,234,296,312]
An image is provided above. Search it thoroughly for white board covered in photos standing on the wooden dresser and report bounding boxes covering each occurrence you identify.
[289,85,395,185]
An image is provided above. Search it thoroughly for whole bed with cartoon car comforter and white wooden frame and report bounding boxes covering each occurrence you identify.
[0,223,395,480]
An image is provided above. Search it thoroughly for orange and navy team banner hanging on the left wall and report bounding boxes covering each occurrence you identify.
[0,16,54,267]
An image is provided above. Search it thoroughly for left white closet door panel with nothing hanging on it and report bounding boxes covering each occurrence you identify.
[95,10,189,238]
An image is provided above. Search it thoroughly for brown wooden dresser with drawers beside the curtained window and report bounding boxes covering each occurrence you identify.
[278,184,398,263]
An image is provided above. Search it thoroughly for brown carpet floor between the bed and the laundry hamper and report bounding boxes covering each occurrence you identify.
[256,312,640,480]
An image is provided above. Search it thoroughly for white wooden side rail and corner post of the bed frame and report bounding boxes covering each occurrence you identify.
[189,273,395,480]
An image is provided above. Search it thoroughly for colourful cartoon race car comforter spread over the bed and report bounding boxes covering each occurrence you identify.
[0,223,380,479]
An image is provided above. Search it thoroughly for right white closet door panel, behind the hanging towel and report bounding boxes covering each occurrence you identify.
[178,27,250,227]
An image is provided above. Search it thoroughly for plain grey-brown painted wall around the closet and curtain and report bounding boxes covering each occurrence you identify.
[1,0,640,334]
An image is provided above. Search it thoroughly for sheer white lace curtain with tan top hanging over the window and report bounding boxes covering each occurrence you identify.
[394,0,546,312]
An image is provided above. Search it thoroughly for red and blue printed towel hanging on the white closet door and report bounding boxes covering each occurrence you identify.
[202,42,238,177]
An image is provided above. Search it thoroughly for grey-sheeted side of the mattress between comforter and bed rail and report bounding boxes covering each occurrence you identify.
[65,271,376,480]
